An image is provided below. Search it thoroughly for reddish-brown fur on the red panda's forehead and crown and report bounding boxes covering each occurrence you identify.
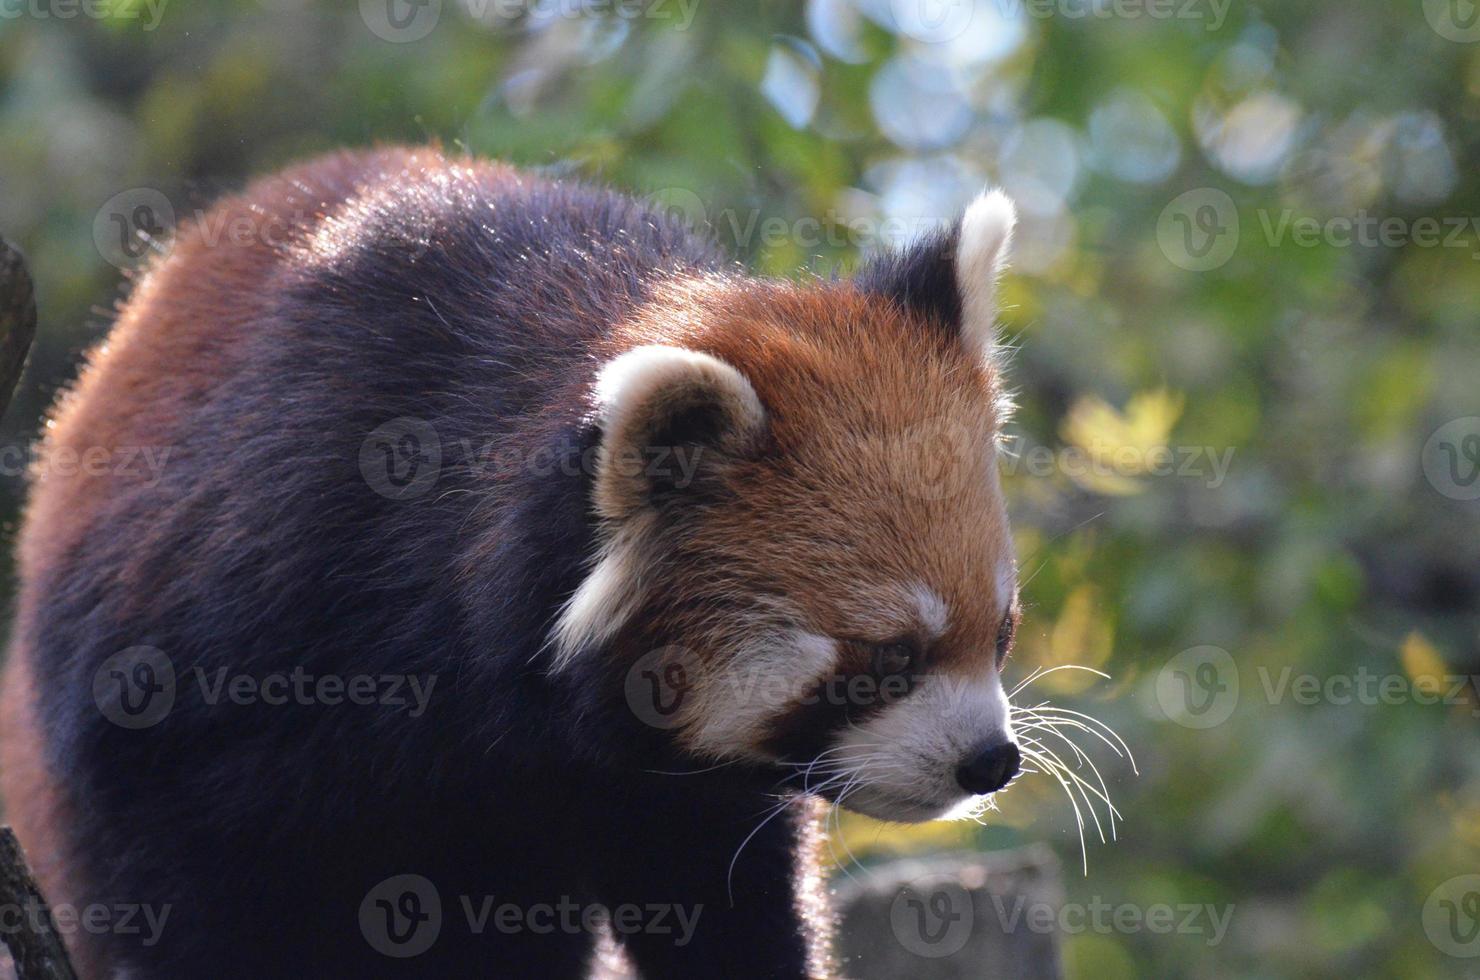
[600,278,1012,683]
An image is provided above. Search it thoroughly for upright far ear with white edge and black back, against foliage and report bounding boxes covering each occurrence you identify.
[855,191,1017,360]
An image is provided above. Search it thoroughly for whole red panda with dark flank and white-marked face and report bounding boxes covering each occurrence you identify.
[0,148,1018,979]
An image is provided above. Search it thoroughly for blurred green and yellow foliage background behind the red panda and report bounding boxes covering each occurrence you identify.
[0,0,1480,977]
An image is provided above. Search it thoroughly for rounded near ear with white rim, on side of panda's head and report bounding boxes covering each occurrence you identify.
[595,345,765,521]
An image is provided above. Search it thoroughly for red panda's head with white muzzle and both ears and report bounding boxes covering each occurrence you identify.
[552,194,1018,820]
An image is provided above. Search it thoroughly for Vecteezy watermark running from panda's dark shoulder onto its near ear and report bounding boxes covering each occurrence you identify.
[358,416,706,500]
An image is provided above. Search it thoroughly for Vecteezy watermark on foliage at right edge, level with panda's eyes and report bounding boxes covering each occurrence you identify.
[1156,647,1480,728]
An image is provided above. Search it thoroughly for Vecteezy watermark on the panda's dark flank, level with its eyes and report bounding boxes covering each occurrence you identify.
[93,647,437,728]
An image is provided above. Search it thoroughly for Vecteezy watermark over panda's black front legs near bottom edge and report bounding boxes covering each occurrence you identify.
[360,875,704,959]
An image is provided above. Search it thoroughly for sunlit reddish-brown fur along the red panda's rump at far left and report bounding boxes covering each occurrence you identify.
[0,148,491,976]
